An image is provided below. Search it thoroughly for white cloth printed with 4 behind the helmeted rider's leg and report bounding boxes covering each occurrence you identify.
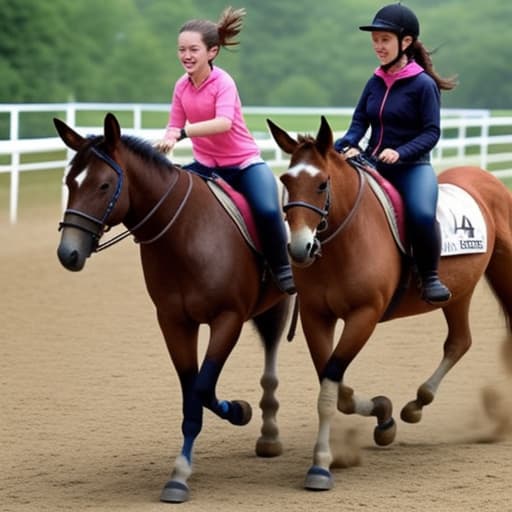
[437,183,487,256]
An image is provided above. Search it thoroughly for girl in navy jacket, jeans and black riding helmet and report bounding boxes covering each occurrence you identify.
[335,3,455,304]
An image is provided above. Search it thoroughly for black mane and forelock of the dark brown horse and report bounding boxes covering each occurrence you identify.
[68,135,174,179]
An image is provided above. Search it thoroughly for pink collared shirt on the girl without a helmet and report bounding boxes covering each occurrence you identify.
[167,66,261,168]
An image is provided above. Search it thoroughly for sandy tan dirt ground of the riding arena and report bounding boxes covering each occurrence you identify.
[0,205,512,512]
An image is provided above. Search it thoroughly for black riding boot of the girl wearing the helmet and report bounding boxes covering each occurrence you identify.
[414,221,452,304]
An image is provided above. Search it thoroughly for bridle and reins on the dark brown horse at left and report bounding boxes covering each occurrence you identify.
[59,146,192,252]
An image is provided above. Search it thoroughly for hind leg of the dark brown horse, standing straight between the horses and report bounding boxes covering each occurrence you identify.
[253,297,290,457]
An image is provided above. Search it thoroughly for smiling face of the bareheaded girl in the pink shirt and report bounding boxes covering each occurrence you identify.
[178,31,219,84]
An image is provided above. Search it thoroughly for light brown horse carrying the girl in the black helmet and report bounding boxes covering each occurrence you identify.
[269,118,512,490]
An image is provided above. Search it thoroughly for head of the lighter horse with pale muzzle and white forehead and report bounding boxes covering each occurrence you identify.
[267,116,341,267]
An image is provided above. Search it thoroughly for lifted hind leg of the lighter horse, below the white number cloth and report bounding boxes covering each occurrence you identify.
[400,294,472,423]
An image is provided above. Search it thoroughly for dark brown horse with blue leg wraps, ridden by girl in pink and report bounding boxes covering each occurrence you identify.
[54,114,289,502]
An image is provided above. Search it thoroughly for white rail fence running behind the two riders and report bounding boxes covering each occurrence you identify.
[0,103,512,223]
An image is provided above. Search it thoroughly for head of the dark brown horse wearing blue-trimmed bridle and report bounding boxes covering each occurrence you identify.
[54,113,129,271]
